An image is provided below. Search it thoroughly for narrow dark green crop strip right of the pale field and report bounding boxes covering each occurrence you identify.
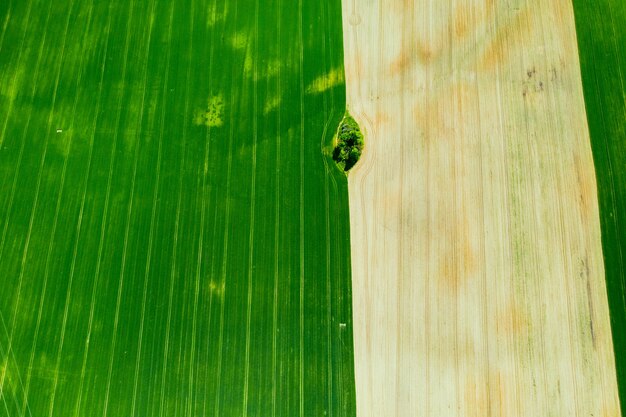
[574,0,626,415]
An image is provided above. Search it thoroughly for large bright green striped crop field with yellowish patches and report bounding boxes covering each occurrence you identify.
[0,0,355,417]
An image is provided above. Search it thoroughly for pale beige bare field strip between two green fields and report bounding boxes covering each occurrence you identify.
[343,0,619,417]
